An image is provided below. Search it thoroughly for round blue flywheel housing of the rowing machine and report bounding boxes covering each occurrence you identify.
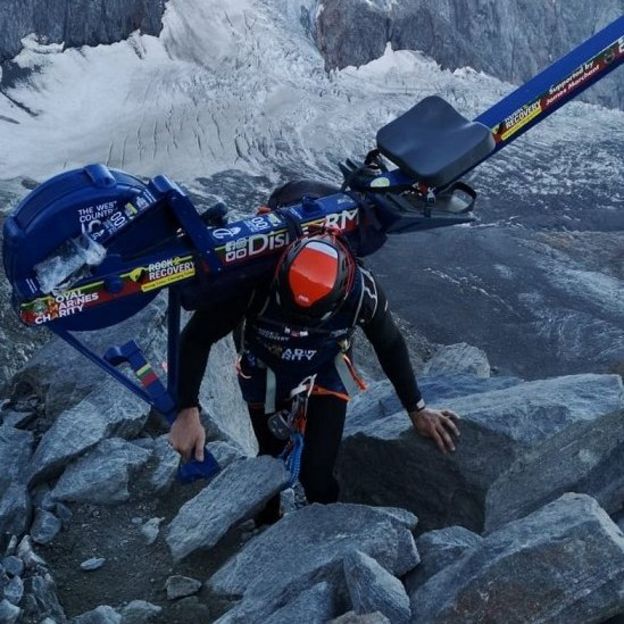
[2,164,178,331]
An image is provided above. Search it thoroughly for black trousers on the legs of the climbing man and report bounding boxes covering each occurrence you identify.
[249,395,347,524]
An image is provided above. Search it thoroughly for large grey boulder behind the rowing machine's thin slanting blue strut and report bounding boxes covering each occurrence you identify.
[22,297,166,485]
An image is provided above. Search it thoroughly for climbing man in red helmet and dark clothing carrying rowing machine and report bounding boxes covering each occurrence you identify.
[169,185,459,524]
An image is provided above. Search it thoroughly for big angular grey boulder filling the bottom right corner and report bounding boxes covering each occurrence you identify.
[410,494,624,624]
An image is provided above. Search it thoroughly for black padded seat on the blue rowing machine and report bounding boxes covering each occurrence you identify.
[377,95,496,188]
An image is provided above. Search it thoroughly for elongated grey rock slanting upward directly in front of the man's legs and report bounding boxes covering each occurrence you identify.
[166,456,289,561]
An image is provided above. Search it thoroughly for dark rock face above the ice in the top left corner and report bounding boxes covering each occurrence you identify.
[0,0,165,62]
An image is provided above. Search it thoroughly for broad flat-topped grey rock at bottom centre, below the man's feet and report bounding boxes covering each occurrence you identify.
[208,504,419,624]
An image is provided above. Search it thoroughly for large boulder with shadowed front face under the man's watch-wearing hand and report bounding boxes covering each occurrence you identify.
[339,375,624,533]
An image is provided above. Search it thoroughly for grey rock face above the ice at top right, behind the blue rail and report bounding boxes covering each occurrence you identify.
[316,0,624,106]
